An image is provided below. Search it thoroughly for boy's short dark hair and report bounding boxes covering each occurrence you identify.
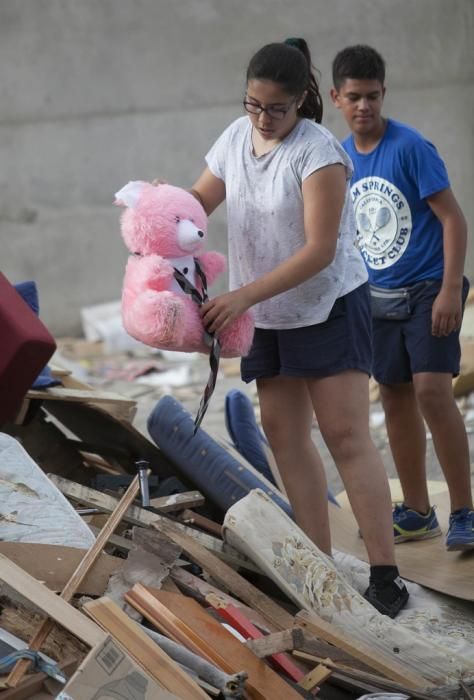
[332,44,385,90]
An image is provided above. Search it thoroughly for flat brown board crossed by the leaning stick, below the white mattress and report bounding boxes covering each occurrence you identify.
[0,538,123,596]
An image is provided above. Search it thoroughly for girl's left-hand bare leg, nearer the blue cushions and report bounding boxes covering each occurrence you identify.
[257,376,331,555]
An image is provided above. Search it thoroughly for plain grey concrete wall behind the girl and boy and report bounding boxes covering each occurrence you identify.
[0,0,474,334]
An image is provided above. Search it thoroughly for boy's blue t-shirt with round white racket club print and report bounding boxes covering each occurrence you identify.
[342,119,449,289]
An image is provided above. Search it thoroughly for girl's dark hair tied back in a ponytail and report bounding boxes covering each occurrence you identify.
[247,39,323,123]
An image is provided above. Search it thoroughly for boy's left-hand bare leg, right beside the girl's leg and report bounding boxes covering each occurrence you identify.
[380,382,430,513]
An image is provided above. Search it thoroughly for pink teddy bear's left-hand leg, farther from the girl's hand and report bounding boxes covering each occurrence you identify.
[122,289,187,347]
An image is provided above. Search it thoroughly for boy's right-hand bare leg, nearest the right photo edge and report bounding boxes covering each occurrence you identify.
[413,372,473,511]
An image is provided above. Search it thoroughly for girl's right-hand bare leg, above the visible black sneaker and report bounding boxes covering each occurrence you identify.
[306,370,395,566]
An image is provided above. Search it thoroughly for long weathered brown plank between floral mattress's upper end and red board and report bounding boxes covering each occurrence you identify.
[153,521,293,630]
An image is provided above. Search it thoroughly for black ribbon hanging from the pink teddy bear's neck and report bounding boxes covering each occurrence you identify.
[174,258,221,435]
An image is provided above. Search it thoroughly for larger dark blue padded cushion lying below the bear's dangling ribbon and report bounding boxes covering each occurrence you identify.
[147,396,292,516]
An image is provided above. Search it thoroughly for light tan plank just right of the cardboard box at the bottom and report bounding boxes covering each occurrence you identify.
[84,598,209,700]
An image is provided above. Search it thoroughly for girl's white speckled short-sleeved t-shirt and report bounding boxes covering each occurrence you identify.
[206,116,367,329]
